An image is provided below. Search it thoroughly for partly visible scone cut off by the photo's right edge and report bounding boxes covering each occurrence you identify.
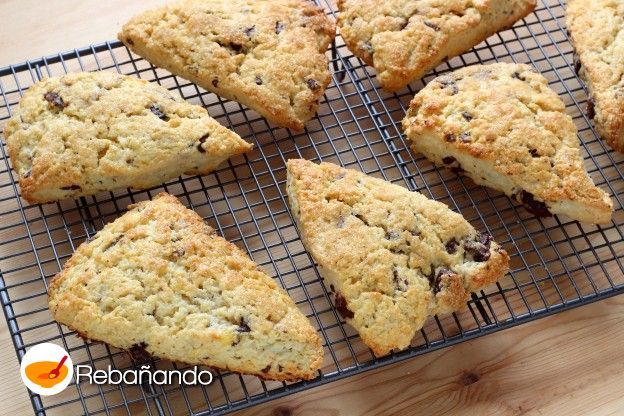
[566,0,624,152]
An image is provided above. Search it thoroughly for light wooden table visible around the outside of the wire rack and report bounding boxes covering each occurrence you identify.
[0,0,624,416]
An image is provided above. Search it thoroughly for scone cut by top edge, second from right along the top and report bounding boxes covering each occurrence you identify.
[338,0,536,91]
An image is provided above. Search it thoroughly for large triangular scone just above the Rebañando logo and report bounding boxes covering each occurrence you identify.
[49,193,323,380]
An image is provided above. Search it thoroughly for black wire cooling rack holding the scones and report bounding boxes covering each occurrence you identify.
[0,0,624,415]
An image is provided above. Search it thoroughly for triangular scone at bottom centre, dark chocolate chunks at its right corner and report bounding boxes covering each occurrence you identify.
[287,160,509,357]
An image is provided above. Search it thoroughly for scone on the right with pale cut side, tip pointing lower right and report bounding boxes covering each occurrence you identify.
[403,63,613,224]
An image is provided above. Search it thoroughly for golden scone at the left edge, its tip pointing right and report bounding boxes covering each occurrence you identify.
[4,72,252,203]
